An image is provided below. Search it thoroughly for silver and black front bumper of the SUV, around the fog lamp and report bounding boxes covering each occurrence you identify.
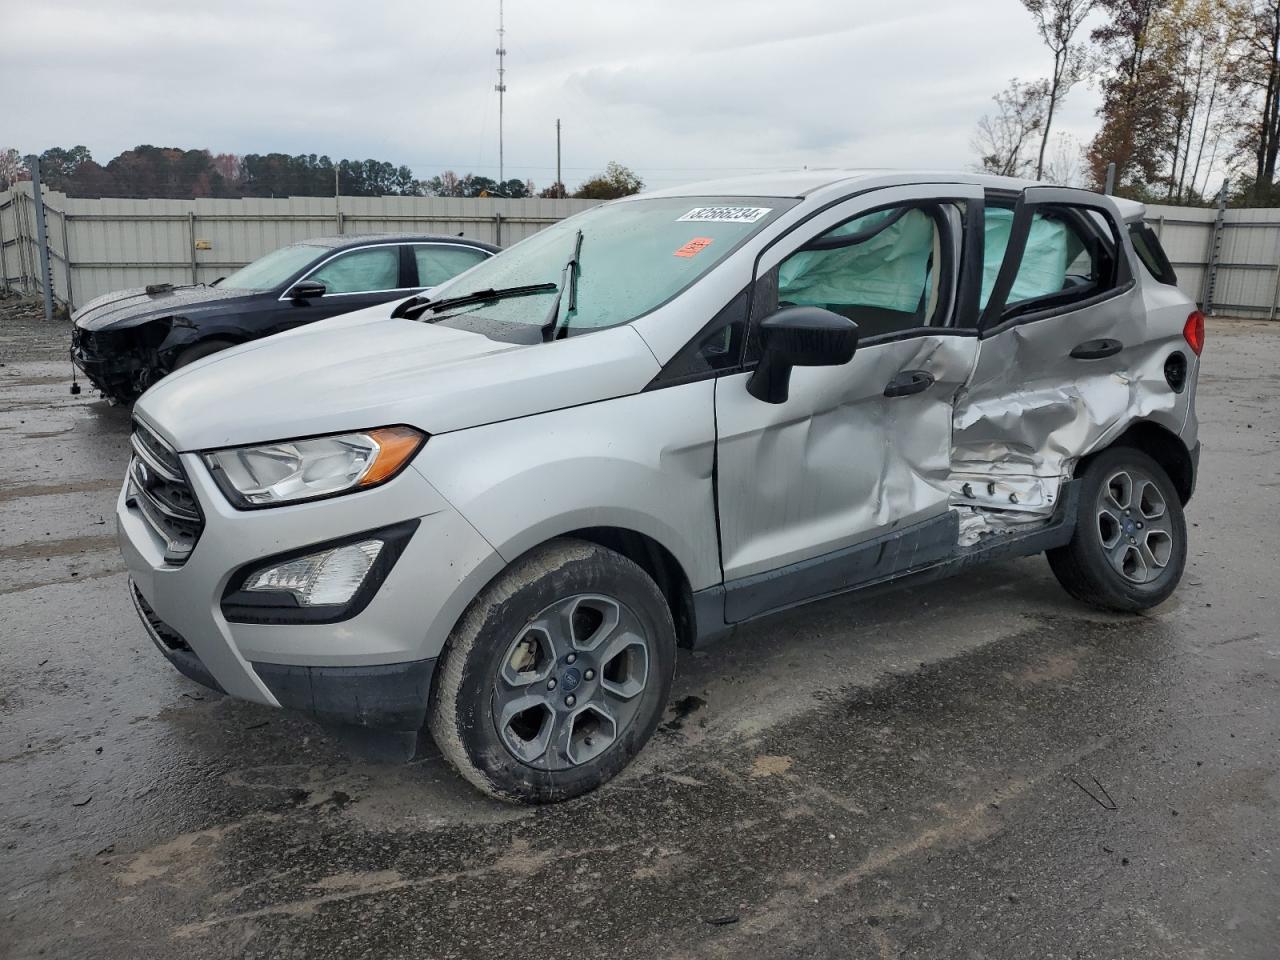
[116,453,502,731]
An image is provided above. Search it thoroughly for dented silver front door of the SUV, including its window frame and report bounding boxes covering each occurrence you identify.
[716,184,982,622]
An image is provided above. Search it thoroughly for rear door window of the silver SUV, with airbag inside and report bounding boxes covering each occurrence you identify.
[979,206,1115,316]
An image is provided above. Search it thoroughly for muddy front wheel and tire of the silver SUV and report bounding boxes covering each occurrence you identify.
[428,539,676,804]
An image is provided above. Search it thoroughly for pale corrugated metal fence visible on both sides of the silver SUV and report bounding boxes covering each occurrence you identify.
[0,183,1280,319]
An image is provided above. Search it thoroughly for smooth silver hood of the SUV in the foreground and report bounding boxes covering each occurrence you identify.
[136,305,659,451]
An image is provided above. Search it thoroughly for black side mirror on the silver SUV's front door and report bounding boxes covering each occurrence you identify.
[746,307,858,403]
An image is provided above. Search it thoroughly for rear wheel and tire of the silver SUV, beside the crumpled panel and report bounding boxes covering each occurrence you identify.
[1047,447,1187,613]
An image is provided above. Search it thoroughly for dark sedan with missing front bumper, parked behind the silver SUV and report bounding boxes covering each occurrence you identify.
[72,234,498,403]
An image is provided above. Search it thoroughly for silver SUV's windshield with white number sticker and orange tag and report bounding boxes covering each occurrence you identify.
[422,197,796,334]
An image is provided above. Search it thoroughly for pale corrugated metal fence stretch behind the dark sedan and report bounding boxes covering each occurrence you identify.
[0,183,598,310]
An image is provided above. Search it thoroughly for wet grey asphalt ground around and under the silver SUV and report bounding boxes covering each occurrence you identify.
[0,309,1280,960]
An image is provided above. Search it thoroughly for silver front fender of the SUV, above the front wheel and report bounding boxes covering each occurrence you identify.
[413,380,722,591]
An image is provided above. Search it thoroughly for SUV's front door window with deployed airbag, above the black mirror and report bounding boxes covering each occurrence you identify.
[777,205,950,339]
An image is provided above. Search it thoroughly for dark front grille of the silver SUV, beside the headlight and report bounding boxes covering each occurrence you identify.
[128,420,205,564]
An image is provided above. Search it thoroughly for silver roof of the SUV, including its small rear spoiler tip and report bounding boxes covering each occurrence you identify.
[643,168,1144,220]
